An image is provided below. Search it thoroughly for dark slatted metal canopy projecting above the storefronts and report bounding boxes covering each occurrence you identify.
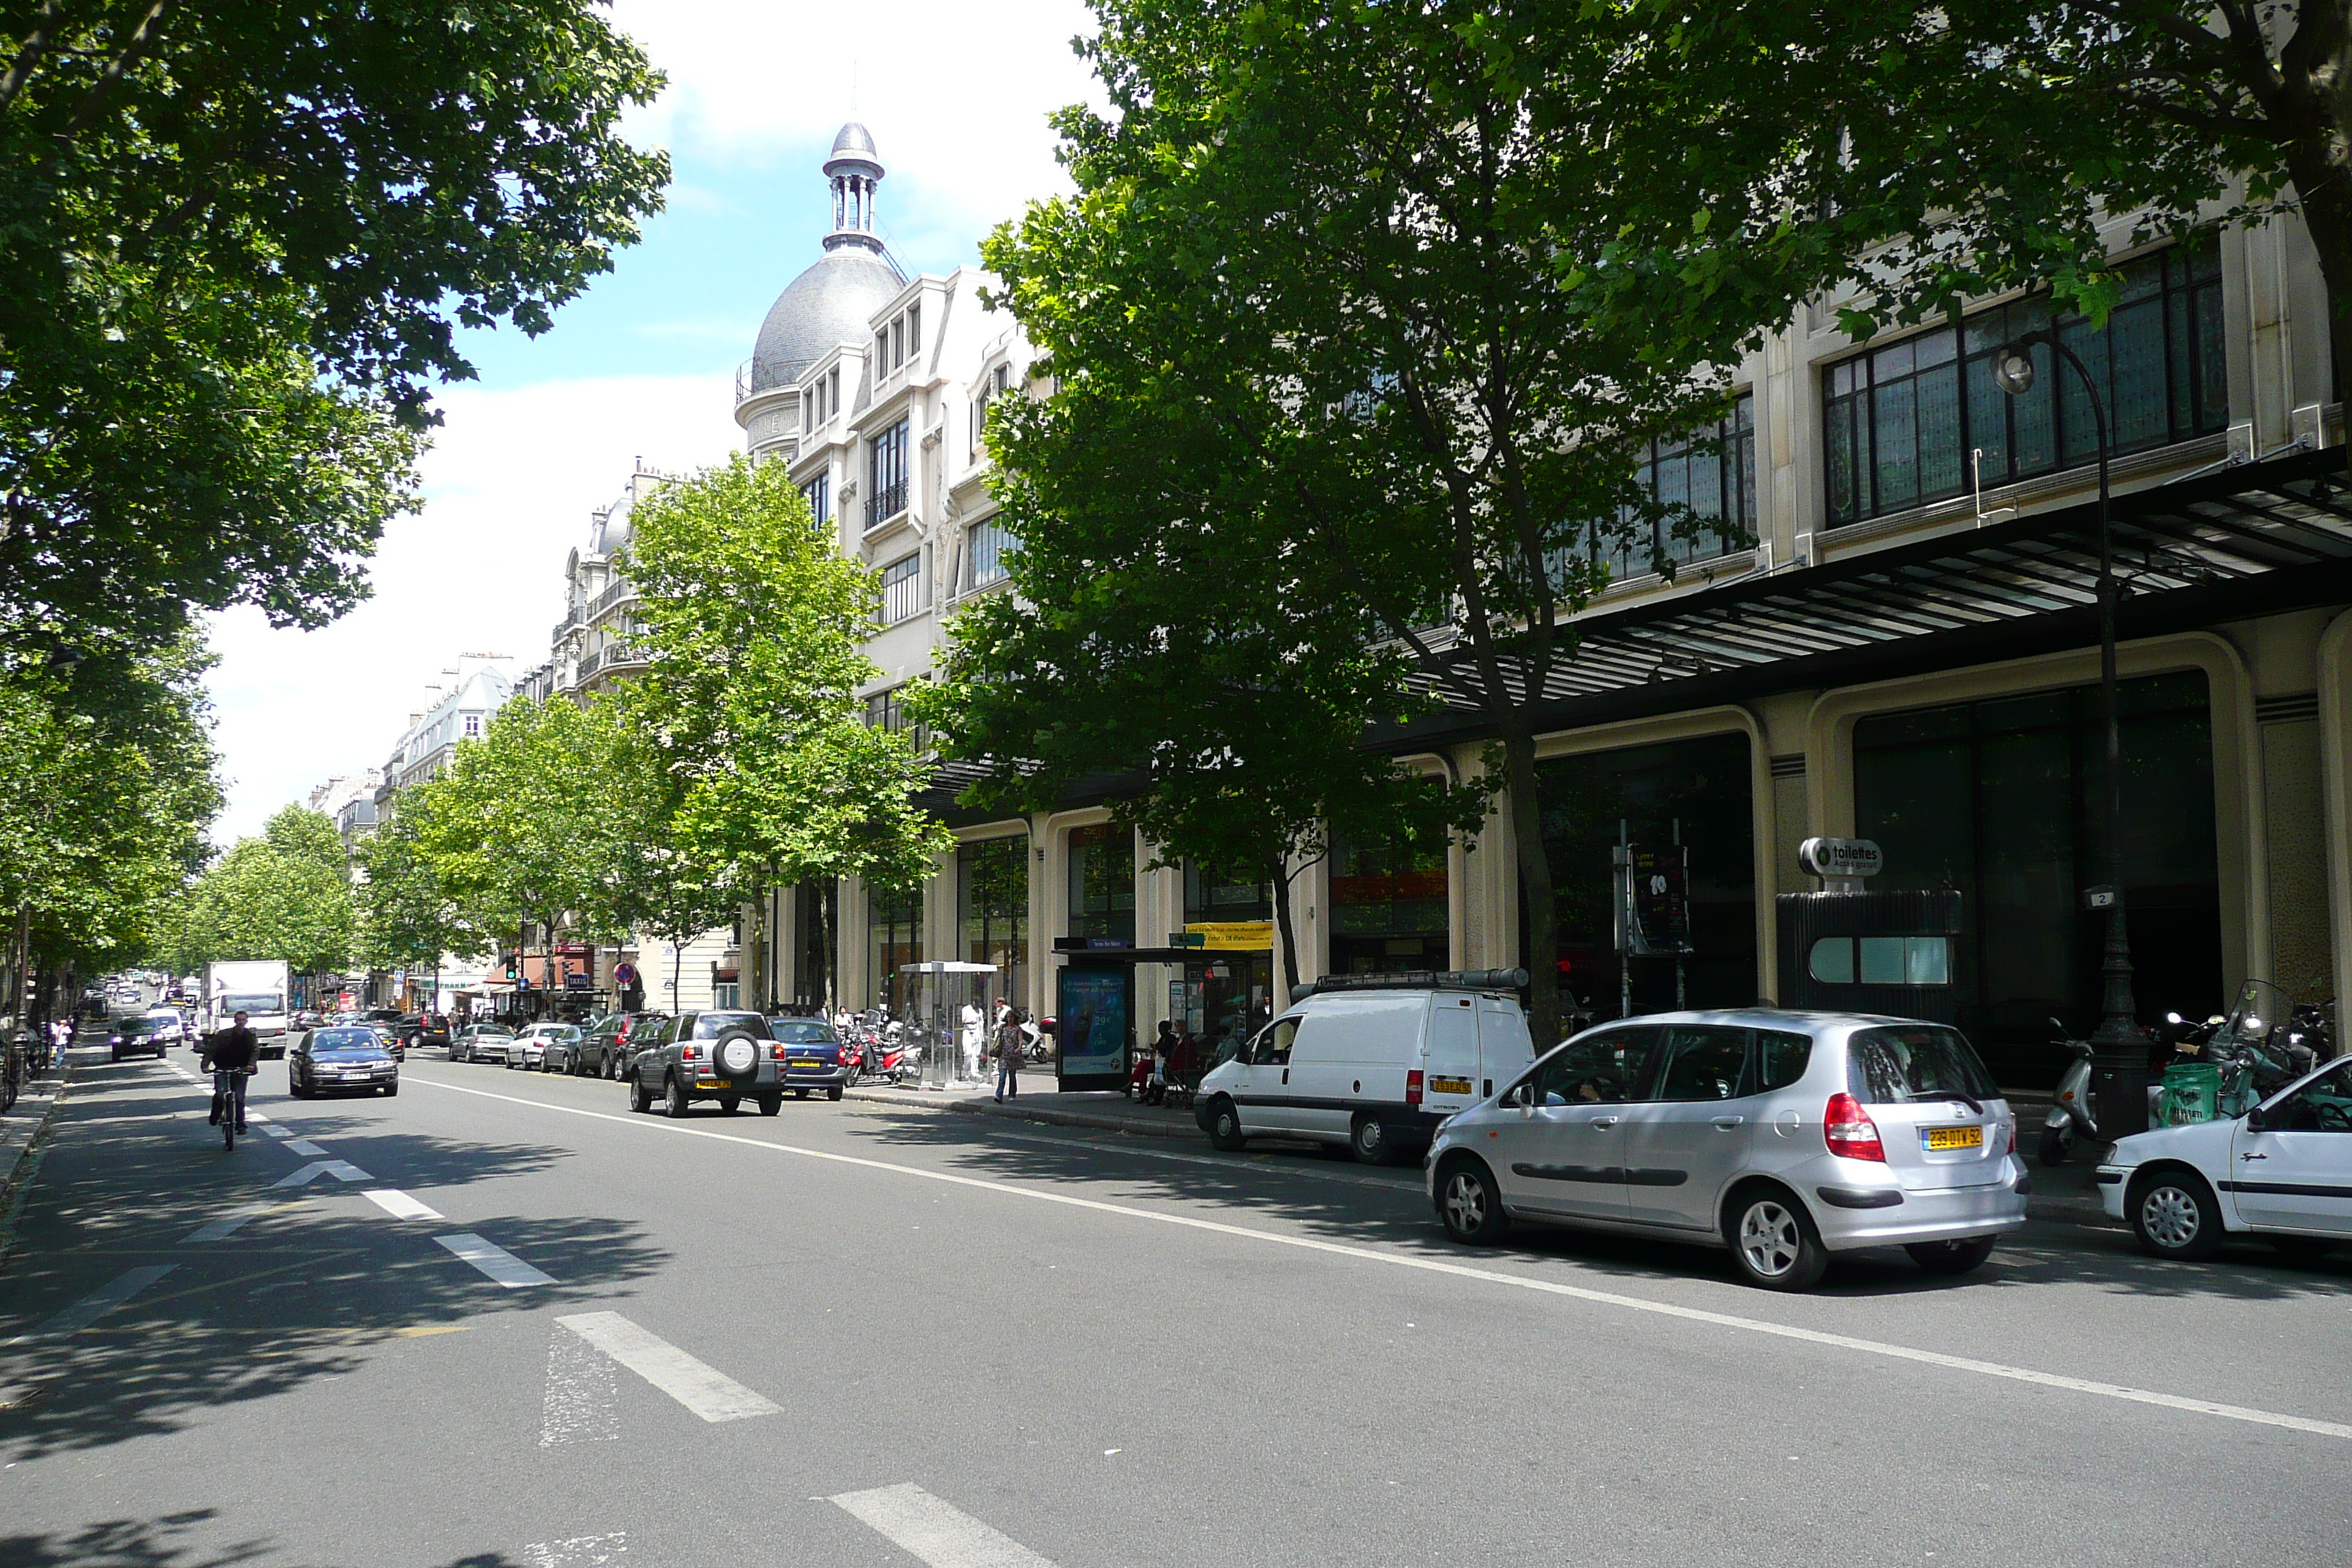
[1383,449,2352,750]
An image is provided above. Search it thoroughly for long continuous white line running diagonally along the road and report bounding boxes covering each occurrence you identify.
[414,1079,2352,1441]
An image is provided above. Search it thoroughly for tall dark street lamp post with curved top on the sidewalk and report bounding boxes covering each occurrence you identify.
[1992,327,2147,1138]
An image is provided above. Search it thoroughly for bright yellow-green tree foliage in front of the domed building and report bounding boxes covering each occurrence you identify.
[623,453,950,987]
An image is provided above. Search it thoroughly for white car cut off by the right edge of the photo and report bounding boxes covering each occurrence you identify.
[2098,1055,2352,1258]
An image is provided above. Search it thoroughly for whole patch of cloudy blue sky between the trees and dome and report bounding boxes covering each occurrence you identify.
[209,0,1101,846]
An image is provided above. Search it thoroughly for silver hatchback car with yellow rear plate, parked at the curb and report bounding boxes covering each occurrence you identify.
[1423,1009,2029,1291]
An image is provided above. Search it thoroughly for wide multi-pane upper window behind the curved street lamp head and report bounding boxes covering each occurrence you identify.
[1820,249,2230,524]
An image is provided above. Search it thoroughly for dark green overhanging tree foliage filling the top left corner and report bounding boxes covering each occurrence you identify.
[0,0,668,642]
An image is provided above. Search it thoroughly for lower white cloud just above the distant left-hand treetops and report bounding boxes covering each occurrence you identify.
[209,376,741,846]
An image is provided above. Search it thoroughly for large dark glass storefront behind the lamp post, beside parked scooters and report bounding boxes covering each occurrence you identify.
[1853,670,2223,1086]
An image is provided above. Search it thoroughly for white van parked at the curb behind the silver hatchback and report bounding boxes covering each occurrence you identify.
[1193,968,1536,1166]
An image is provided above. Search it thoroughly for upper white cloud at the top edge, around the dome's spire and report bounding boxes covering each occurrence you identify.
[614,0,1101,256]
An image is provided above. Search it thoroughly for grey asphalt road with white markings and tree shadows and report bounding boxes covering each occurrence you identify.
[0,1051,2352,1568]
